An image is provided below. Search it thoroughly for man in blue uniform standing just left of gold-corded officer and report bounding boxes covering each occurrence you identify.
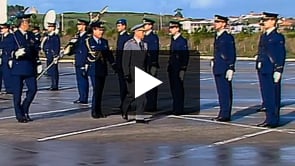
[73,19,89,104]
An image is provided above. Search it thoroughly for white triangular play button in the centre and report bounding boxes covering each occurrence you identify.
[135,66,163,98]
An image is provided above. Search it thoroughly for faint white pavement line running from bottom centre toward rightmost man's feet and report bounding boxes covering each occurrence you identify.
[144,129,273,163]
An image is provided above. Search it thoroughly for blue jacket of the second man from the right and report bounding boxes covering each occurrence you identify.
[213,31,236,75]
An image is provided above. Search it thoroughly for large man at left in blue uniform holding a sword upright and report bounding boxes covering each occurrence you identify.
[10,14,39,123]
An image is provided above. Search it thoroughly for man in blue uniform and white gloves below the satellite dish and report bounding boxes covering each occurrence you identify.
[42,23,60,91]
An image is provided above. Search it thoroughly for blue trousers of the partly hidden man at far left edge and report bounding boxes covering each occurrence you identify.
[2,58,13,93]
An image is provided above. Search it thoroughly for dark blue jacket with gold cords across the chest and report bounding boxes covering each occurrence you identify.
[85,37,114,76]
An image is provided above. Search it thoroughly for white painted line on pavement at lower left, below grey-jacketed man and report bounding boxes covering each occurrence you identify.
[37,121,136,142]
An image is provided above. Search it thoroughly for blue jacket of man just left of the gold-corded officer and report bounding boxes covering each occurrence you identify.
[74,33,88,67]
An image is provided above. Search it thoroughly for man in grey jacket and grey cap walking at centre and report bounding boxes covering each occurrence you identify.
[122,23,148,123]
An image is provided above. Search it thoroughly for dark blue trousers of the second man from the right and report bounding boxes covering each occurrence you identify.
[214,74,233,118]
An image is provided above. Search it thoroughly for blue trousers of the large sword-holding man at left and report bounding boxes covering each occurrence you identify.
[13,75,37,119]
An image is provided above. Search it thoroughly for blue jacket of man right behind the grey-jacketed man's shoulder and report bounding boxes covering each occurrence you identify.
[143,32,159,67]
